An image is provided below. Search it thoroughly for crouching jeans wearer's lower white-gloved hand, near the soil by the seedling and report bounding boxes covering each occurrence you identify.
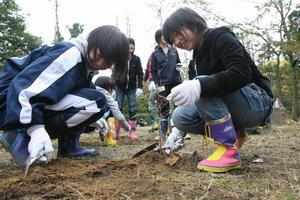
[163,127,184,154]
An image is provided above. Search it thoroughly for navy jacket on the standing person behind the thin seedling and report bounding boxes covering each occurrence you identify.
[149,47,182,86]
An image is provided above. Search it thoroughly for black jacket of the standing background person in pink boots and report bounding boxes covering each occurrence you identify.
[116,54,144,90]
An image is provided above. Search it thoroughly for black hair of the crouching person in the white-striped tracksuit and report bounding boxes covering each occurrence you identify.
[87,25,129,75]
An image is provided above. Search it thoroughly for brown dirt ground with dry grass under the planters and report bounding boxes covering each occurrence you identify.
[0,111,300,200]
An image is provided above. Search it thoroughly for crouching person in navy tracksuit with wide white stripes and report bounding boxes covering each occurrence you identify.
[0,26,128,165]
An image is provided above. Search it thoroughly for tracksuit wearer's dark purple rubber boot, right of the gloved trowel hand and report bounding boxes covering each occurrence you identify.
[57,133,100,158]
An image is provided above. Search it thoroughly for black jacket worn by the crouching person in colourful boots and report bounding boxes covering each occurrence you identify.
[193,27,273,98]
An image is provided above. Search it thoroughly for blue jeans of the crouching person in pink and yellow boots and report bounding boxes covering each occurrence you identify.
[172,83,273,134]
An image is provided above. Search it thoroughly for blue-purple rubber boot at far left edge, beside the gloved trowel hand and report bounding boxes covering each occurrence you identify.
[0,129,30,167]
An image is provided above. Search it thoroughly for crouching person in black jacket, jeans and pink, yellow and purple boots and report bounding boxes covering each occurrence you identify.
[163,8,273,172]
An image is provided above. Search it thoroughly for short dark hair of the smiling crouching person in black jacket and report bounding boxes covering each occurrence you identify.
[162,7,207,45]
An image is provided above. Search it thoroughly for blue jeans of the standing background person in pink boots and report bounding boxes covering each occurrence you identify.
[116,87,136,120]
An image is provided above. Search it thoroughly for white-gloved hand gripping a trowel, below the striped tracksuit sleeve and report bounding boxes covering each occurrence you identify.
[27,125,54,161]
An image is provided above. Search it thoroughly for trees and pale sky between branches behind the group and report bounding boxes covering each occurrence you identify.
[0,0,300,120]
